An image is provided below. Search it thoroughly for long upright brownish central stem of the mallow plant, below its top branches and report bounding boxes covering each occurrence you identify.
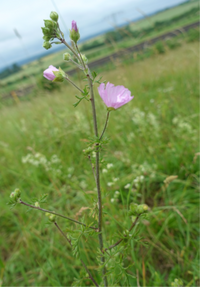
[87,74,108,287]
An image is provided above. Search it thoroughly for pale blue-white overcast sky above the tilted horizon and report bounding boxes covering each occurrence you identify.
[0,0,187,68]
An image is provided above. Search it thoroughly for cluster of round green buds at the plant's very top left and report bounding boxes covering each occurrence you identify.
[42,12,62,50]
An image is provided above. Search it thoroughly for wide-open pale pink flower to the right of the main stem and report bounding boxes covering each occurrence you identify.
[98,82,133,109]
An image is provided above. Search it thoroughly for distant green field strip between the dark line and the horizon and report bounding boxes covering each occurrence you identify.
[0,1,199,98]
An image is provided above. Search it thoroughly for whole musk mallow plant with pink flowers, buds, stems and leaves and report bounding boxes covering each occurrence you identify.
[9,12,148,287]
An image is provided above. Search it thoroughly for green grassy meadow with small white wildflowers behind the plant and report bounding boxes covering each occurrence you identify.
[0,43,200,287]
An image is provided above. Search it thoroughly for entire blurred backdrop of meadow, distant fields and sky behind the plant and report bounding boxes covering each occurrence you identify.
[0,0,200,287]
